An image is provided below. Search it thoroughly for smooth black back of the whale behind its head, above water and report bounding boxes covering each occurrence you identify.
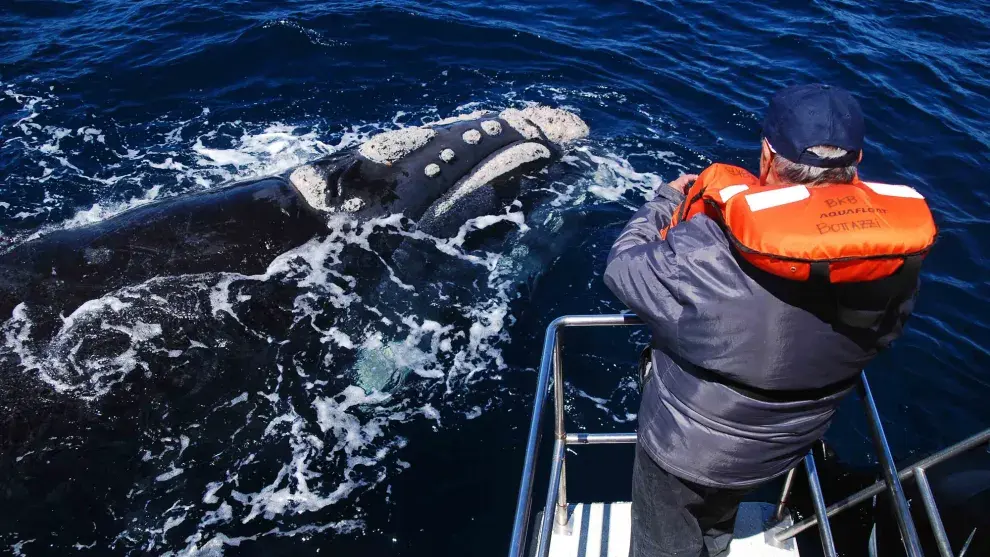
[0,178,326,317]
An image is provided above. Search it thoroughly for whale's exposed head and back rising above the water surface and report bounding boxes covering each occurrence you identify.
[0,106,589,323]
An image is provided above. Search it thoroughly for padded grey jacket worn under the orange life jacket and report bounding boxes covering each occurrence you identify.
[605,186,918,488]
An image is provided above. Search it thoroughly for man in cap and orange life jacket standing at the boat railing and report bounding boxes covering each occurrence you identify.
[605,85,936,557]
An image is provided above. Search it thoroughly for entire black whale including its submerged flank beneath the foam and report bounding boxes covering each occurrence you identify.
[0,107,588,552]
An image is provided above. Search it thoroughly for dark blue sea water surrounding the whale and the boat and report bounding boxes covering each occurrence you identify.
[0,0,990,555]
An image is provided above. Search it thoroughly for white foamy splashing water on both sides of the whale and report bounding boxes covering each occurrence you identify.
[0,78,672,555]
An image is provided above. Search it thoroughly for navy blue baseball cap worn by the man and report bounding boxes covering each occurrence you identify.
[763,83,864,168]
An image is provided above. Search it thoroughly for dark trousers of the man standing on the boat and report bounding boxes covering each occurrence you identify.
[629,445,751,557]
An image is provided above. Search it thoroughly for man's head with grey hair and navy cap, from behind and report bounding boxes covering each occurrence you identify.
[760,84,863,185]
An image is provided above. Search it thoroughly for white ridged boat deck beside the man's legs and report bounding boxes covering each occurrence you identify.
[550,503,799,557]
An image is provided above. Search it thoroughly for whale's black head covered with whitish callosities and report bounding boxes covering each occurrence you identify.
[289,106,589,222]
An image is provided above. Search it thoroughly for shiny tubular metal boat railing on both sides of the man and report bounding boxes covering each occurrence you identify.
[509,314,990,557]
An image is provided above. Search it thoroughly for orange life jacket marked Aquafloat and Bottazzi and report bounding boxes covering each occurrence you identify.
[660,164,938,283]
